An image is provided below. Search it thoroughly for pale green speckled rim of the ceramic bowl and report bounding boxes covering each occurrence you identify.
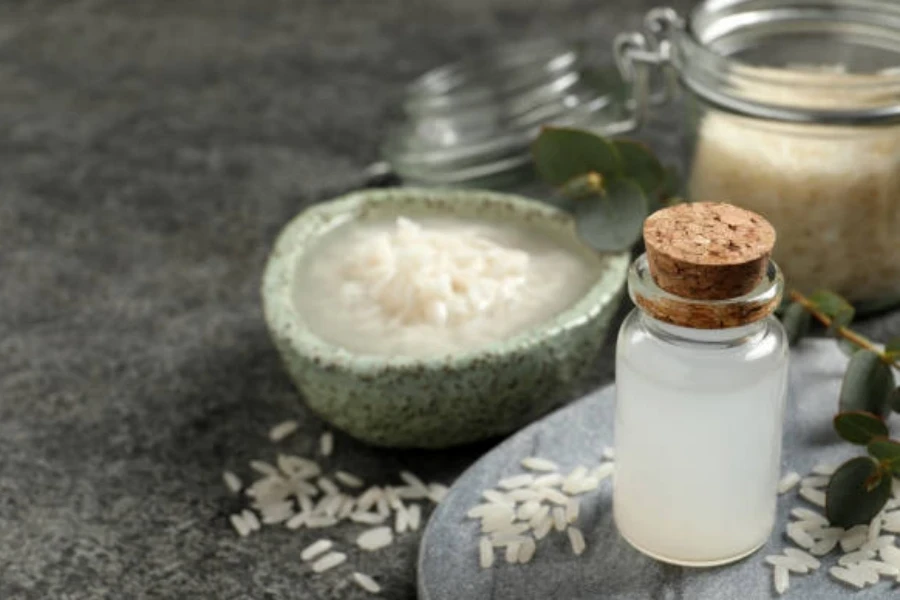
[261,187,630,374]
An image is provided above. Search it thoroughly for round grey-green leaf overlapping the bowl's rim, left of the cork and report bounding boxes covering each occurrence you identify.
[574,179,647,252]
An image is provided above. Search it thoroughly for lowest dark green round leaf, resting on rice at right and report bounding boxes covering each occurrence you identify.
[825,456,891,528]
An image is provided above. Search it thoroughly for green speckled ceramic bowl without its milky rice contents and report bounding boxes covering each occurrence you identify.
[262,188,629,448]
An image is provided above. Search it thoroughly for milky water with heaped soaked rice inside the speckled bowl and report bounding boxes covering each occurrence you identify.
[294,216,603,356]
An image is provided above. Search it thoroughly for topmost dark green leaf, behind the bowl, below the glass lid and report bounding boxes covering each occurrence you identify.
[531,127,621,186]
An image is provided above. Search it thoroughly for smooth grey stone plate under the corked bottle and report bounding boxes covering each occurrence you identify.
[419,340,898,600]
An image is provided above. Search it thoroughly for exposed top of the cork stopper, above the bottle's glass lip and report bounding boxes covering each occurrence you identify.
[644,202,775,300]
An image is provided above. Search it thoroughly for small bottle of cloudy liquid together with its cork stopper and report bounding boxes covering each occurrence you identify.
[613,203,788,566]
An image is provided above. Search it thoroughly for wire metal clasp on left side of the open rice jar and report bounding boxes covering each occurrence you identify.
[613,7,684,133]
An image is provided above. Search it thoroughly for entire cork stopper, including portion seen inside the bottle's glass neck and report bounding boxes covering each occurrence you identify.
[636,202,778,329]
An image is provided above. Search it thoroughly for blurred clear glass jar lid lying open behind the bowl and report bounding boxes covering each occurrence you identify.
[382,40,623,188]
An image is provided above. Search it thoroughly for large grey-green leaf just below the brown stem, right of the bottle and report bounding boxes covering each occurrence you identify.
[838,350,896,417]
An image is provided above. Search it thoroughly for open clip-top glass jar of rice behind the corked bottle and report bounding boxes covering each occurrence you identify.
[616,0,900,310]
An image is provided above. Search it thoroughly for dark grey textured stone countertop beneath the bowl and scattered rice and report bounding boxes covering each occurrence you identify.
[0,0,900,600]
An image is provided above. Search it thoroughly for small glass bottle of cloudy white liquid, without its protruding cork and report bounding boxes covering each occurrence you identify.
[613,255,788,566]
